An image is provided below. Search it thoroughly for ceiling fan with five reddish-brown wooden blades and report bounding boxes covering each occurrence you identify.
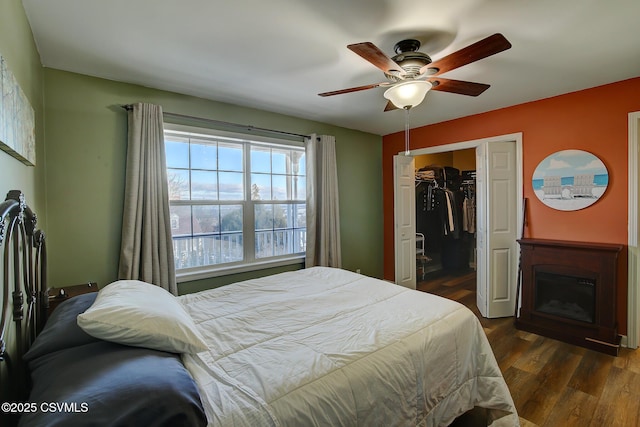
[318,33,511,111]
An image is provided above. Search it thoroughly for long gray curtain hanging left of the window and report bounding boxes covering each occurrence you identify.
[118,103,178,295]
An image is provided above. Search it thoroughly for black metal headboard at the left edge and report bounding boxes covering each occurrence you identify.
[0,190,48,402]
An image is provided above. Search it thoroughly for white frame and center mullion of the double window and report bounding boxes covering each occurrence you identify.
[164,122,306,283]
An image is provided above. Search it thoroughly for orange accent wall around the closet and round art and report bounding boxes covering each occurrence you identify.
[382,77,640,333]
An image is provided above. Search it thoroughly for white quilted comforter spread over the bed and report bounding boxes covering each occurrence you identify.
[180,267,519,427]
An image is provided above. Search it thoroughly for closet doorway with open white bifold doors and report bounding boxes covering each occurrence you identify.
[394,134,523,317]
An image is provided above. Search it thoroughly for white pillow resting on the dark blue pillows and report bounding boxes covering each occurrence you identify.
[77,280,207,353]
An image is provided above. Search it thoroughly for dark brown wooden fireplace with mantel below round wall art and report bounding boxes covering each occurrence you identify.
[515,239,623,355]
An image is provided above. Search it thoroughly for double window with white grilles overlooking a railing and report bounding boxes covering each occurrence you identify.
[165,125,307,276]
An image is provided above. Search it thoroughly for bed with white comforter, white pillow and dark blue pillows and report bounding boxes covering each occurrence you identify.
[0,191,519,426]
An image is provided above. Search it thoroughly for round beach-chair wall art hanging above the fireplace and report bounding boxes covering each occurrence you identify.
[532,150,609,211]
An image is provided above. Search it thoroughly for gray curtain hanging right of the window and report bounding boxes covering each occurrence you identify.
[306,134,342,267]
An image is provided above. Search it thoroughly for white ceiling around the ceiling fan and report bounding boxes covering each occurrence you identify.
[23,0,640,135]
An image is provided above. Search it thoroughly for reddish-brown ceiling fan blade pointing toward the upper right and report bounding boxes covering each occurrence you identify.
[420,33,511,76]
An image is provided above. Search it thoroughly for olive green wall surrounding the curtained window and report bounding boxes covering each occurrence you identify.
[44,69,383,293]
